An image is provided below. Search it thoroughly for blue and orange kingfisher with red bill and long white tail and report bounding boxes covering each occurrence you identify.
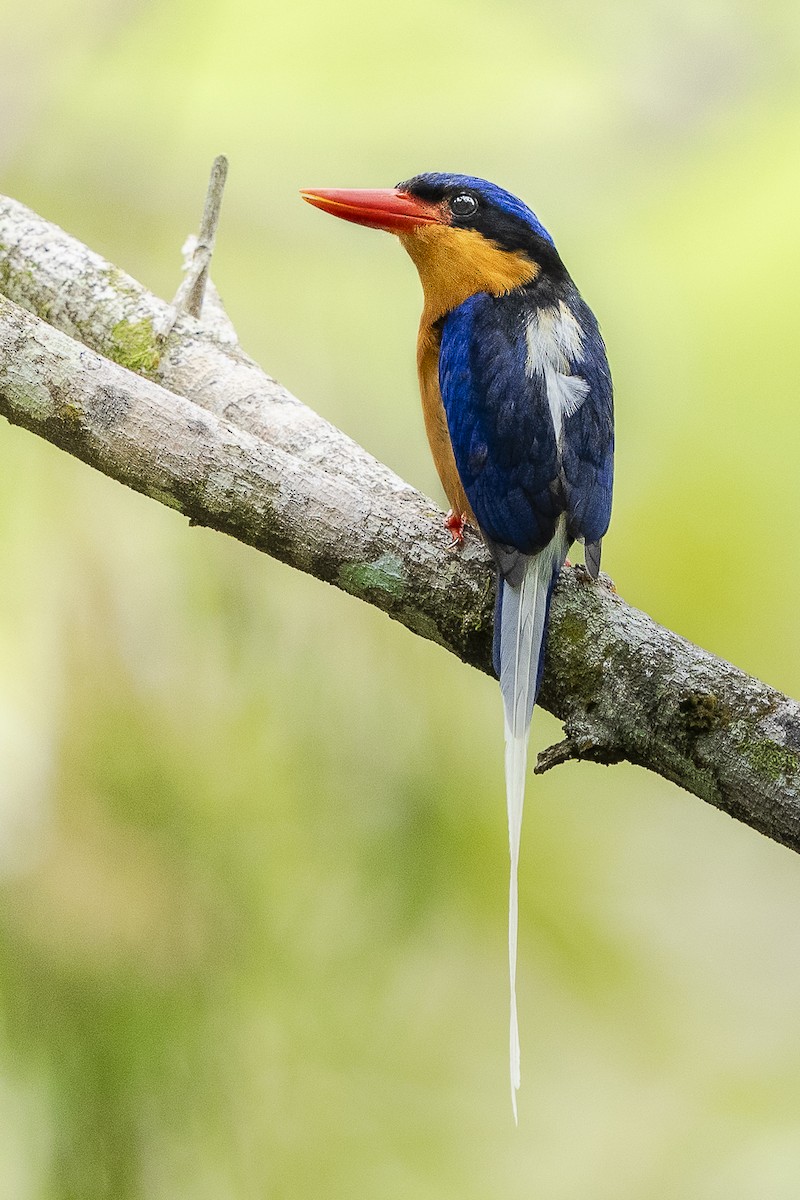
[301,172,614,1122]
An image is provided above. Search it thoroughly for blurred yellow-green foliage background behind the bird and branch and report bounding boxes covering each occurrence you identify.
[0,0,800,1200]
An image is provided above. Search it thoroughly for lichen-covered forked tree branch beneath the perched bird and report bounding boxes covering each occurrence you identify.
[0,189,800,850]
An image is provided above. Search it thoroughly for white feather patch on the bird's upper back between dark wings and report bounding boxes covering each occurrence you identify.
[525,301,589,444]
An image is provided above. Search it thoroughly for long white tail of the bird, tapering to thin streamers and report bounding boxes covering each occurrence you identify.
[498,523,567,1121]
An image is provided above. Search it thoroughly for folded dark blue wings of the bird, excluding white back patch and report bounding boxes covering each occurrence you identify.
[439,286,613,561]
